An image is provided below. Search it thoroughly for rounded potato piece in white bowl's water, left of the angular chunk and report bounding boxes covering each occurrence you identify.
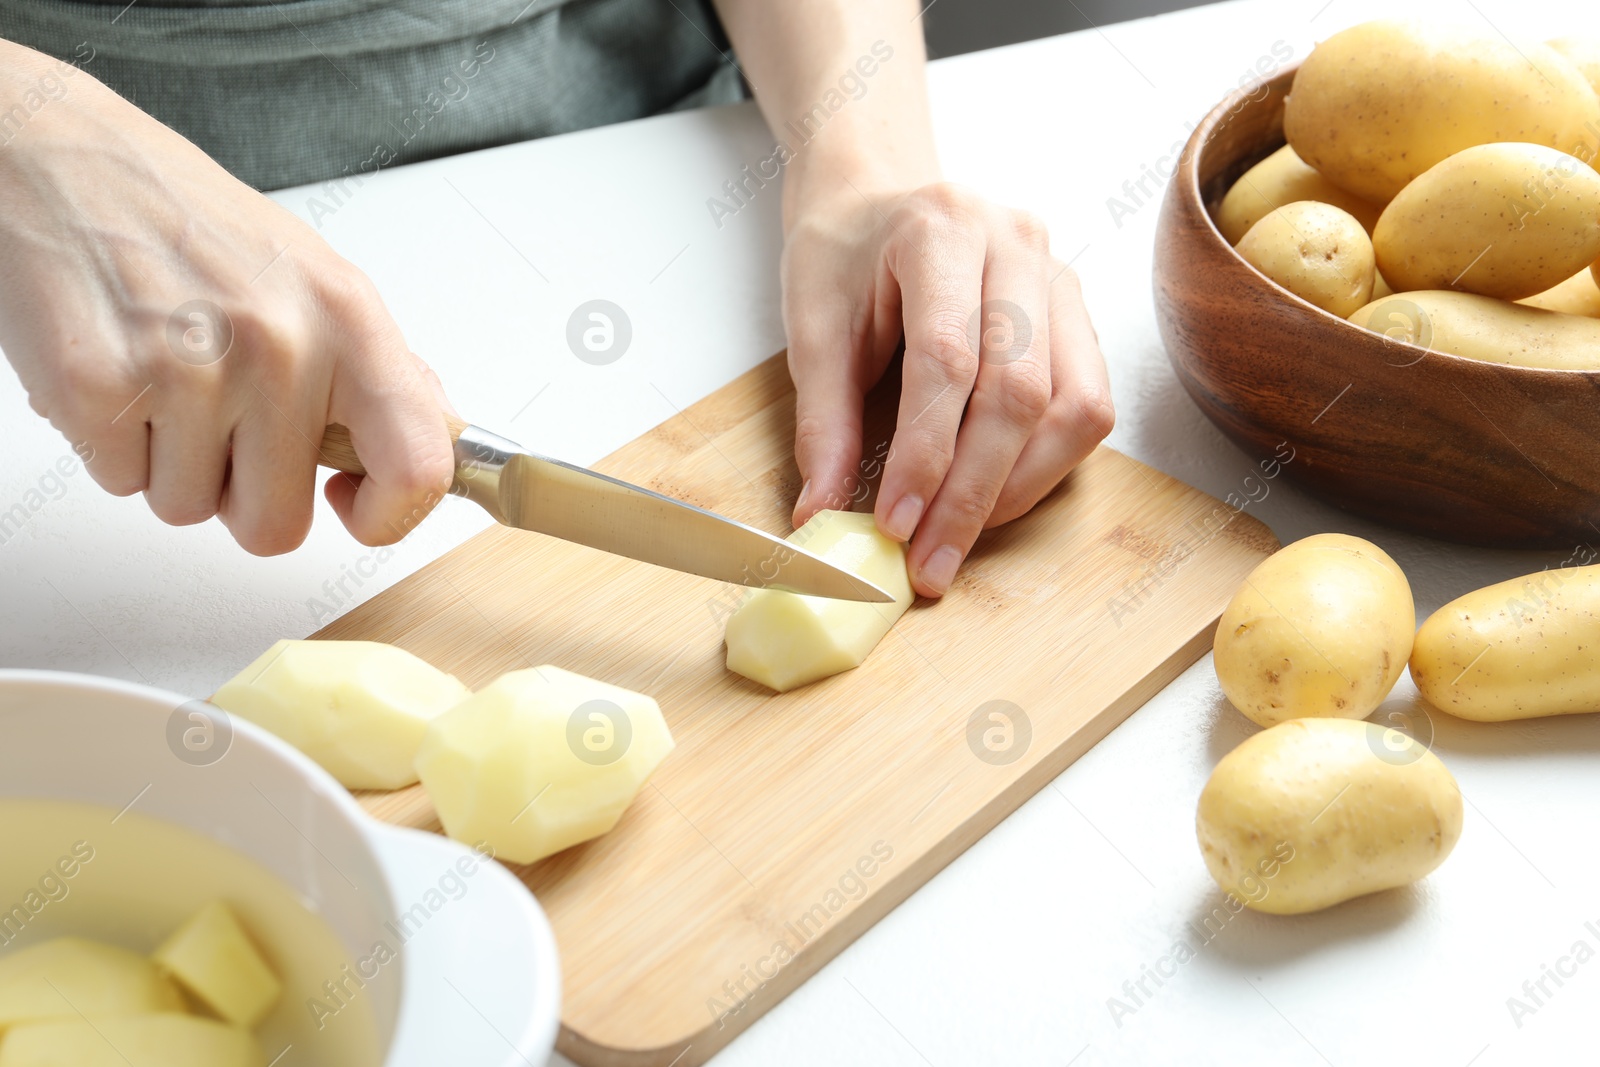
[0,937,186,1033]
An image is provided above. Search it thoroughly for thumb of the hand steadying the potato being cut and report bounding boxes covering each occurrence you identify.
[789,330,867,526]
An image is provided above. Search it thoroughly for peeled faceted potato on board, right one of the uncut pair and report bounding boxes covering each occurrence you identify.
[416,665,672,864]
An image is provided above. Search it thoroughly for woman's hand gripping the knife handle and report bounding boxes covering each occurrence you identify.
[0,43,454,555]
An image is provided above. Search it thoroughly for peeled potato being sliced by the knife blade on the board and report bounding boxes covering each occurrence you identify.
[726,512,915,693]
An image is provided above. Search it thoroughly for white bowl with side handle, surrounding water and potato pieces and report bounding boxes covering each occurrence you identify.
[0,670,562,1067]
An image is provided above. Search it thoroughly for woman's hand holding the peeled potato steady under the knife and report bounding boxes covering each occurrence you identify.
[782,181,1114,597]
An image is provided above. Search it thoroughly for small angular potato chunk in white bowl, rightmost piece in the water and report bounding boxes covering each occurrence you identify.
[150,901,283,1029]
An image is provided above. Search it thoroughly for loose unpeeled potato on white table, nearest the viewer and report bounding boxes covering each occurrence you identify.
[1195,718,1462,915]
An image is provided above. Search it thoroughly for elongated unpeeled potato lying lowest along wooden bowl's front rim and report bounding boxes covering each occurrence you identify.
[1350,290,1600,371]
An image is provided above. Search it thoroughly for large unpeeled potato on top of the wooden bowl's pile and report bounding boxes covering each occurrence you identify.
[1283,21,1600,202]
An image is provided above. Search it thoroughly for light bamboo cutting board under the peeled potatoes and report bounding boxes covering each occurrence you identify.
[317,355,1277,1067]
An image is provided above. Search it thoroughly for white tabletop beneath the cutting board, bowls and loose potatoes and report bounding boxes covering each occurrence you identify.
[0,0,1600,1067]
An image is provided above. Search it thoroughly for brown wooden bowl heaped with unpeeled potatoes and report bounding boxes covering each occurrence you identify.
[1154,21,1600,547]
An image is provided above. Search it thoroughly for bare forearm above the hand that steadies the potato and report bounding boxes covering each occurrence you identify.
[715,0,939,229]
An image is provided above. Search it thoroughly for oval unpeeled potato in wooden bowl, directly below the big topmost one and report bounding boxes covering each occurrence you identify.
[1369,144,1600,300]
